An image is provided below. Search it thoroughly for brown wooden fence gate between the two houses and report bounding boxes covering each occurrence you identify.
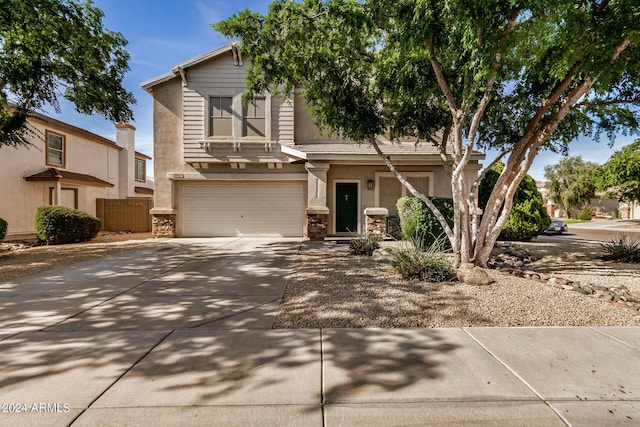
[96,199,153,233]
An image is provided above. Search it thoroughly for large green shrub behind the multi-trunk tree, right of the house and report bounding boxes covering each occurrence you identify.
[478,163,551,241]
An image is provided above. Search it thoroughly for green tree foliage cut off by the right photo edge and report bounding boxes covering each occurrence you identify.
[597,139,640,202]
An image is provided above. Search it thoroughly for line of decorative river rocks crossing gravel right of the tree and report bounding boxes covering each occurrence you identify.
[487,243,640,312]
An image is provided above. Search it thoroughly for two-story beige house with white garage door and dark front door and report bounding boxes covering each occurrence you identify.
[142,44,483,239]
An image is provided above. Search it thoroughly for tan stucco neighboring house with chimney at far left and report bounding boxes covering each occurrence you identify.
[0,114,153,239]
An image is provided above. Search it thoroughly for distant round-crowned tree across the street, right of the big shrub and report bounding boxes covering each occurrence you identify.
[544,156,598,214]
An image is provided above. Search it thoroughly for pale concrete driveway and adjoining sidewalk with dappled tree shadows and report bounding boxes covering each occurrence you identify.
[0,239,640,426]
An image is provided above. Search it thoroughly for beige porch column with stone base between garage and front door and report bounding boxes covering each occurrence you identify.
[305,163,331,240]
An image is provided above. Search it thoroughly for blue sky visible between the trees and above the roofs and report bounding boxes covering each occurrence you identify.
[45,0,635,180]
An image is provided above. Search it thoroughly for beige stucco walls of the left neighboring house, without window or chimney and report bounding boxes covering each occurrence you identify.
[0,120,119,238]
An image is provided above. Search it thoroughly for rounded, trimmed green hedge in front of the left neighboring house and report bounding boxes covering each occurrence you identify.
[36,206,102,245]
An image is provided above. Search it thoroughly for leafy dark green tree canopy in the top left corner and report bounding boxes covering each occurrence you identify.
[0,0,135,147]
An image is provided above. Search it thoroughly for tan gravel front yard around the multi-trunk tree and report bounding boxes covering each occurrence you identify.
[274,240,640,328]
